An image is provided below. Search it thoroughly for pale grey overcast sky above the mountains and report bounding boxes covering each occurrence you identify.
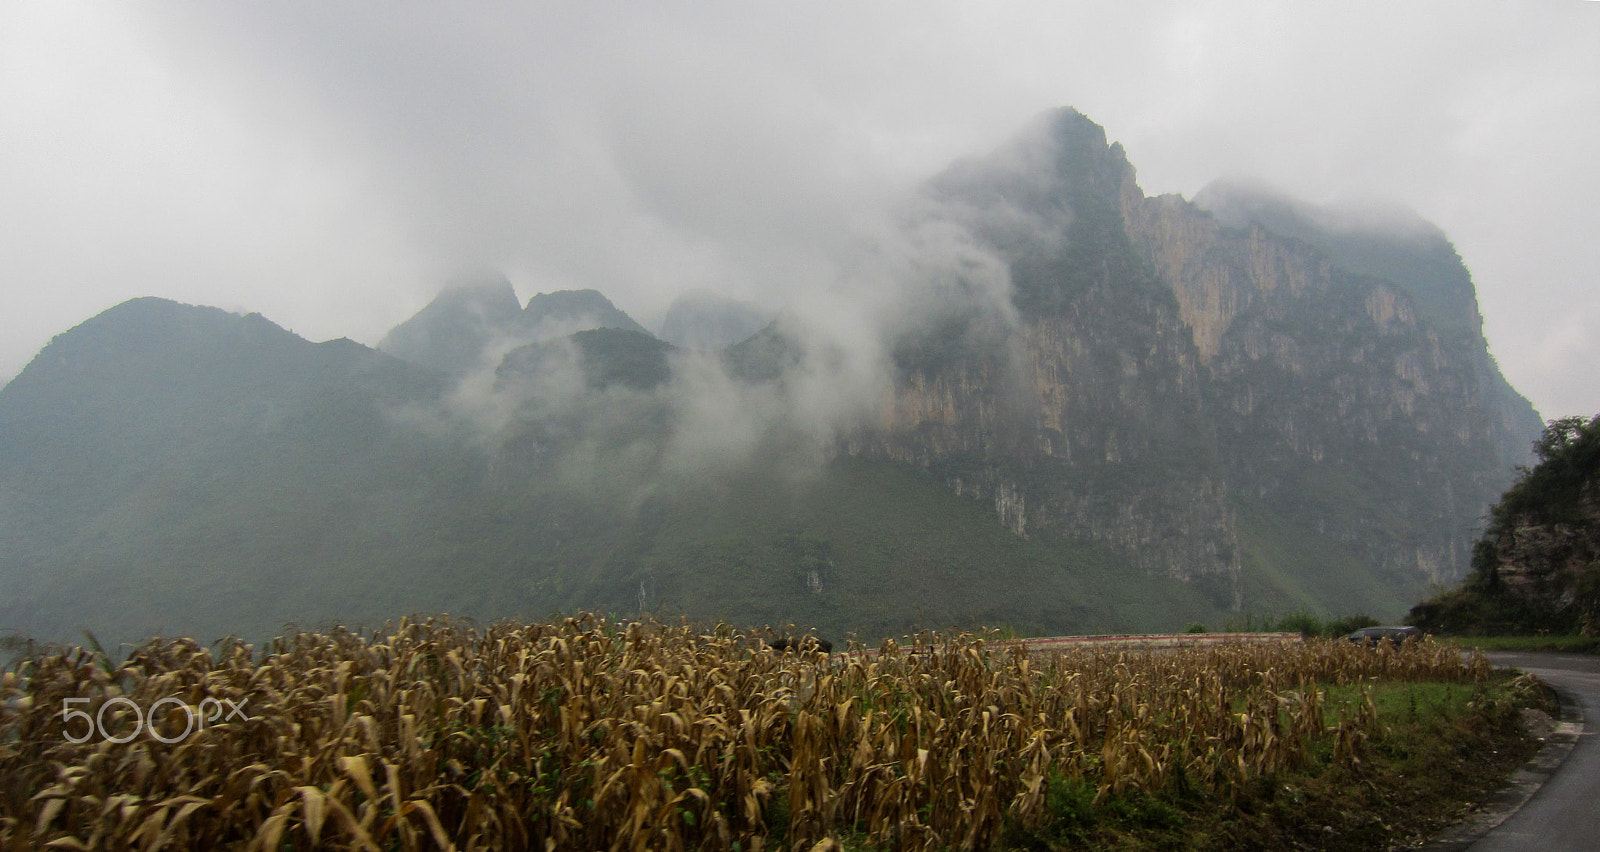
[0,0,1600,418]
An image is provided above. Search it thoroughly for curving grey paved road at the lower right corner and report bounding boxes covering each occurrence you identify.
[1469,653,1600,852]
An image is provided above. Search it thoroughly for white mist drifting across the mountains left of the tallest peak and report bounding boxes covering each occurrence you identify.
[384,158,1024,508]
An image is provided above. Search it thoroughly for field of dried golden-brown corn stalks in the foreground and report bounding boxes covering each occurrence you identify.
[0,617,1488,850]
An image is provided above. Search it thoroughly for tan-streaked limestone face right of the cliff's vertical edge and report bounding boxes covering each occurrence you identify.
[1125,184,1538,583]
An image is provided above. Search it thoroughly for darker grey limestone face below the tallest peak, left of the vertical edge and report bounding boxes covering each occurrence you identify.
[851,299,1238,601]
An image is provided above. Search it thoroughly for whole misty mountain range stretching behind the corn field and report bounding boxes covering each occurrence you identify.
[0,109,1542,650]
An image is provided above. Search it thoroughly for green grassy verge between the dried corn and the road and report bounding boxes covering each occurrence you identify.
[1005,673,1555,852]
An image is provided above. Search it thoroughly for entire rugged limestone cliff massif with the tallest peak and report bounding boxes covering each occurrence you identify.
[850,111,1538,609]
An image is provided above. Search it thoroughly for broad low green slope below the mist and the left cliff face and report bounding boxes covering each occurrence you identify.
[582,456,1216,637]
